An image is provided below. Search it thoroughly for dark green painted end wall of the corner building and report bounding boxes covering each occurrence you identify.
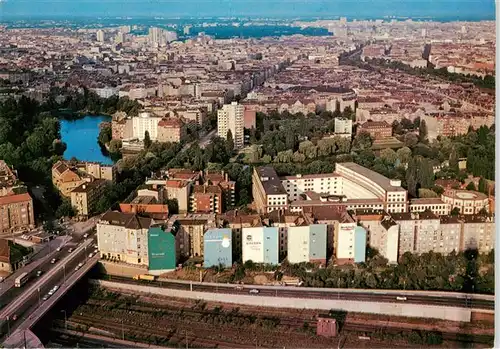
[148,227,177,270]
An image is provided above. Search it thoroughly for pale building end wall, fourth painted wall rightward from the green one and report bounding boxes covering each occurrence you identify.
[288,224,327,265]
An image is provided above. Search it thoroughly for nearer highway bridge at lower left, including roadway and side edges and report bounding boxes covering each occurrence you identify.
[0,239,99,348]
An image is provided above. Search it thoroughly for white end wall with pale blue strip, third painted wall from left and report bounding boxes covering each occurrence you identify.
[242,227,280,265]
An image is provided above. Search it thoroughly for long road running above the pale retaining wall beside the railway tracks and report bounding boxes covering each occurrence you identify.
[104,276,494,310]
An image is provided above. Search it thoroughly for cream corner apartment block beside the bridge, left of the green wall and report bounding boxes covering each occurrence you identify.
[97,211,153,266]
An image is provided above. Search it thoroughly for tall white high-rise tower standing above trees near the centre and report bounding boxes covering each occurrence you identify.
[217,102,245,149]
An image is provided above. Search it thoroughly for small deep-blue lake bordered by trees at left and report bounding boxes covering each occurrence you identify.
[61,116,113,164]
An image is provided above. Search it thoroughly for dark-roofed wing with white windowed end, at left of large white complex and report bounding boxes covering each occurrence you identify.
[252,166,288,213]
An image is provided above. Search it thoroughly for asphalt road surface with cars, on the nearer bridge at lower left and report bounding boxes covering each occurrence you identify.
[0,239,94,336]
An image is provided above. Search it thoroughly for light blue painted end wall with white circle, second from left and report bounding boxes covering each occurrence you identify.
[203,229,233,268]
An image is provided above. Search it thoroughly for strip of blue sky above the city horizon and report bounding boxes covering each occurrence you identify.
[0,0,495,21]
